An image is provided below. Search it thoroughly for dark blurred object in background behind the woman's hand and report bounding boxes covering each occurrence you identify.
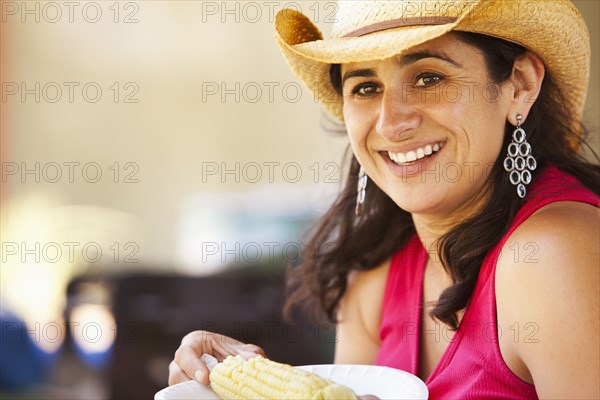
[71,268,335,399]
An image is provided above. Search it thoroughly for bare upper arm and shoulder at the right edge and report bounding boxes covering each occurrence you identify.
[496,202,600,399]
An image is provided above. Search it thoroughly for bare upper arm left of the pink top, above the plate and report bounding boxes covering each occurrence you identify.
[334,260,390,364]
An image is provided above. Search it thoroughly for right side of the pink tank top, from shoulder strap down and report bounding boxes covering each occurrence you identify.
[427,166,600,399]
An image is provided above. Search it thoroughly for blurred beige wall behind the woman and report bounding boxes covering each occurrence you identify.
[1,1,600,320]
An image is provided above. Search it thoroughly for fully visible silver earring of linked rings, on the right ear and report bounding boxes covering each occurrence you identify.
[504,114,537,198]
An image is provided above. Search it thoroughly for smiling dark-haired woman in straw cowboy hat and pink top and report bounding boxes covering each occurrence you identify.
[169,1,600,399]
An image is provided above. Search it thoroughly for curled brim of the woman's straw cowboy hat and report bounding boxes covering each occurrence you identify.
[275,0,590,141]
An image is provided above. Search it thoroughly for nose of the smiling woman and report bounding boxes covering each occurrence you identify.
[375,88,421,141]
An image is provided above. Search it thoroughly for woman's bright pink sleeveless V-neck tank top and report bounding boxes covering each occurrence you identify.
[376,167,600,399]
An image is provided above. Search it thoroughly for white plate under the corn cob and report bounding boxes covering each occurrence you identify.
[154,364,429,400]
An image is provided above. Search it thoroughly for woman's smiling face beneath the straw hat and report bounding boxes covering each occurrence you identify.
[341,34,511,216]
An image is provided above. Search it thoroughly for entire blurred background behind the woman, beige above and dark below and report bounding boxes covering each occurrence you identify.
[0,0,600,399]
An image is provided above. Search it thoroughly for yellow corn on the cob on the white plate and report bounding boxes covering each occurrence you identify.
[210,356,357,400]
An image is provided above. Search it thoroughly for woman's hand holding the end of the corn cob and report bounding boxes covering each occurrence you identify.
[169,331,265,386]
